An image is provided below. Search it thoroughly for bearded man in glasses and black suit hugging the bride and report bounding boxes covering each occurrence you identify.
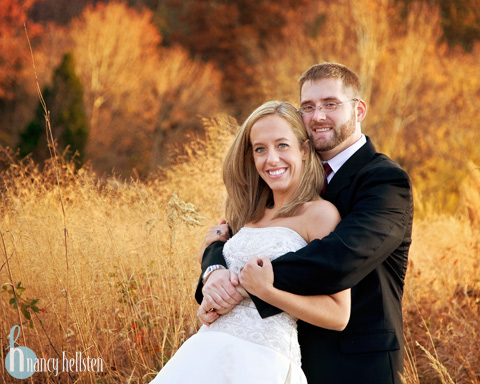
[196,63,413,384]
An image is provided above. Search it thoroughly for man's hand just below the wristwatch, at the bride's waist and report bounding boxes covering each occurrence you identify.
[200,269,243,314]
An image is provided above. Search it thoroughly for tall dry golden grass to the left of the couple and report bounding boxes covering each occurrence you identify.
[0,115,232,383]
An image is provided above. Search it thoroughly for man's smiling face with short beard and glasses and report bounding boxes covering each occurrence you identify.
[300,79,366,160]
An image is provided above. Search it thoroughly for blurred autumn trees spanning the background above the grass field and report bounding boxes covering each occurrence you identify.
[0,0,480,215]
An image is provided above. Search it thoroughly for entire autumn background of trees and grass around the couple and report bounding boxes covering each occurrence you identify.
[0,0,480,384]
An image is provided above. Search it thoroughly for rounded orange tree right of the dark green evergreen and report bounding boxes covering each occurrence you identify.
[71,2,219,174]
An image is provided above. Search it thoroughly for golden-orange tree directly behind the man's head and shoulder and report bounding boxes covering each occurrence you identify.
[258,0,480,216]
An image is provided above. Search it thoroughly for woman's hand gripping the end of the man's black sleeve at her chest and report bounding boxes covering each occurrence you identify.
[239,257,273,300]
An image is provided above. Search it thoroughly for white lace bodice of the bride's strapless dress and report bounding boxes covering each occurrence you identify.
[200,227,307,364]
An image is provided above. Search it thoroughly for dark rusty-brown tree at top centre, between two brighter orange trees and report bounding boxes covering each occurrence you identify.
[152,0,312,117]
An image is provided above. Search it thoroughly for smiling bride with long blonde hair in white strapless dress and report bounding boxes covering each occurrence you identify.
[152,101,350,384]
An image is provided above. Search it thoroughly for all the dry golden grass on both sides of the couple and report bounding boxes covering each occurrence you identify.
[0,119,480,384]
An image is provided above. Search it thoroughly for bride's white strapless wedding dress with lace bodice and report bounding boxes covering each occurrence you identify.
[152,227,307,384]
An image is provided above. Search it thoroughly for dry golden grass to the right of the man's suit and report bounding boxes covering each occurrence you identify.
[404,216,480,383]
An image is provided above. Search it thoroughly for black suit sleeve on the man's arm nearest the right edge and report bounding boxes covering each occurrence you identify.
[252,162,413,317]
